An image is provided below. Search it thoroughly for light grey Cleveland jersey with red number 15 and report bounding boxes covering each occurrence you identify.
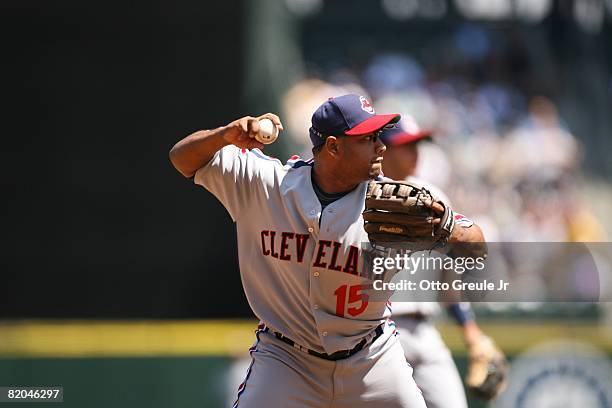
[194,145,391,353]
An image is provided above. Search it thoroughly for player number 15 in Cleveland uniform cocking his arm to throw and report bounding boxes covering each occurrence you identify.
[170,95,482,408]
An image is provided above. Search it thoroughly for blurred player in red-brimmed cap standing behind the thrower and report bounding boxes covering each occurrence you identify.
[381,116,506,408]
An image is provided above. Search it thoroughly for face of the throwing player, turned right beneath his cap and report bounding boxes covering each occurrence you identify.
[341,132,387,181]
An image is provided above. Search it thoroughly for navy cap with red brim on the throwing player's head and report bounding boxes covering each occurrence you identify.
[310,94,400,147]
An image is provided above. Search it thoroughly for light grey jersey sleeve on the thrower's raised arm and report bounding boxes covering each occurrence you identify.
[194,145,280,222]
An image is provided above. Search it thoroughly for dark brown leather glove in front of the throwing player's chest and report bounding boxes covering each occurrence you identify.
[363,180,455,249]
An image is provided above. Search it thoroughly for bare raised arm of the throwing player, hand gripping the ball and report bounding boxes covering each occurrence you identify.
[170,113,283,177]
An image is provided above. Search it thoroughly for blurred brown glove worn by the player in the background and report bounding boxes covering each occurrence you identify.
[465,336,508,400]
